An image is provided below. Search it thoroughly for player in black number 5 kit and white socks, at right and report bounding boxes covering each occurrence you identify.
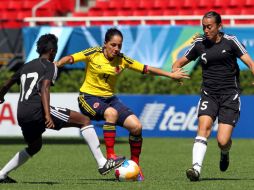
[172,11,254,181]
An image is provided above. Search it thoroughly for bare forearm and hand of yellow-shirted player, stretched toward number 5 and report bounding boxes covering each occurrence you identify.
[147,66,190,79]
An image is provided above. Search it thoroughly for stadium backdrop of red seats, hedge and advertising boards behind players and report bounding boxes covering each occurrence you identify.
[0,0,254,138]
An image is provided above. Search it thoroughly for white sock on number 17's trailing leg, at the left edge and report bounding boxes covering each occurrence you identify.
[0,149,31,179]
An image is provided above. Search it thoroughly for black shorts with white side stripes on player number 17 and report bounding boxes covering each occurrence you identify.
[19,106,70,143]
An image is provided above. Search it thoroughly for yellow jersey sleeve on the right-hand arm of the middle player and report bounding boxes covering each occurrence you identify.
[122,55,147,74]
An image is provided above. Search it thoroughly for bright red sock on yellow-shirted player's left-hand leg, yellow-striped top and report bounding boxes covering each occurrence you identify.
[103,122,116,158]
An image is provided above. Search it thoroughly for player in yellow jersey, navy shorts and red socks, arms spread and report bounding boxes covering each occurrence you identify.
[56,28,189,181]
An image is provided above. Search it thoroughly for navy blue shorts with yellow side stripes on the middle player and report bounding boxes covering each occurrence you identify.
[78,93,133,126]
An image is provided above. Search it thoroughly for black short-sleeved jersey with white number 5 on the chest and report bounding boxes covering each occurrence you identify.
[185,33,247,94]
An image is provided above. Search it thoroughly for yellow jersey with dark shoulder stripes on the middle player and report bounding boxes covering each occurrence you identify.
[71,47,147,97]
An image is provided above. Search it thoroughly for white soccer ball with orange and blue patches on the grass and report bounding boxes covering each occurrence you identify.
[115,160,140,181]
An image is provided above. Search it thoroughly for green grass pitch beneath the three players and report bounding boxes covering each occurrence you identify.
[0,138,254,190]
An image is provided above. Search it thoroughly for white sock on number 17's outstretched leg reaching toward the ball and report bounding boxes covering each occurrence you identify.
[80,125,107,168]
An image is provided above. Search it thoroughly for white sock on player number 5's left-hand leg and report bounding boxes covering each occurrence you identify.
[192,136,207,173]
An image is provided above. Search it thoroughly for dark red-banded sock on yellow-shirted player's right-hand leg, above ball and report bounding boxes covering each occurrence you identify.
[129,134,143,165]
